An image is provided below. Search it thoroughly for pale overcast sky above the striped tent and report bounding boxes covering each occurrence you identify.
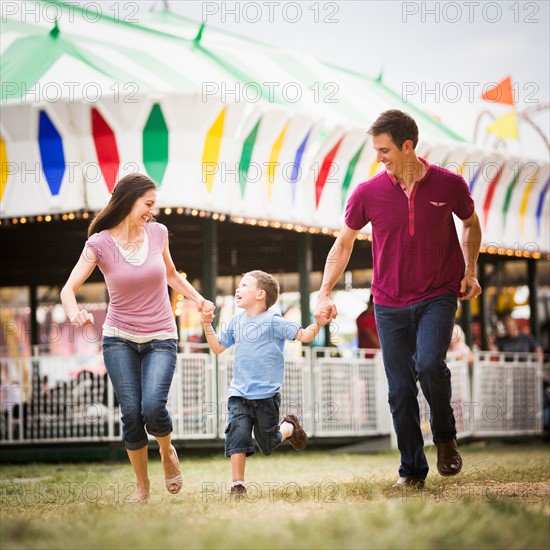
[77,0,550,158]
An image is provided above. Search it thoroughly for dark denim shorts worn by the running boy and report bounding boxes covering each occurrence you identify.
[225,393,282,456]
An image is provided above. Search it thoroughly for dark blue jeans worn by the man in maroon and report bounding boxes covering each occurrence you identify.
[374,293,458,478]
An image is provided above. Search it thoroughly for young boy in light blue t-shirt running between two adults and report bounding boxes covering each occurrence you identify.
[201,270,329,500]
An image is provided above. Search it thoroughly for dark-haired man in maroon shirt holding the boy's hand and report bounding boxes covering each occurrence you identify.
[315,110,481,488]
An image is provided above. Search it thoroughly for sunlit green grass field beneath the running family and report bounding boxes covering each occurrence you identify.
[0,443,550,550]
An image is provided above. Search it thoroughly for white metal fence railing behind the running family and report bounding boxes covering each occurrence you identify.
[0,352,548,445]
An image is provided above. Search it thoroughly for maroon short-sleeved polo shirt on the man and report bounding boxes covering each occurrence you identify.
[345,159,474,307]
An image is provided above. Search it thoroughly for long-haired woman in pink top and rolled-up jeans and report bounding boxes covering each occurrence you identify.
[61,174,214,503]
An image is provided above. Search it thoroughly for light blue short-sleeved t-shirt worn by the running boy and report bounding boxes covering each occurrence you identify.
[219,310,301,399]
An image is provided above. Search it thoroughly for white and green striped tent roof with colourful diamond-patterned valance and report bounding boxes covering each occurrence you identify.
[0,2,550,251]
